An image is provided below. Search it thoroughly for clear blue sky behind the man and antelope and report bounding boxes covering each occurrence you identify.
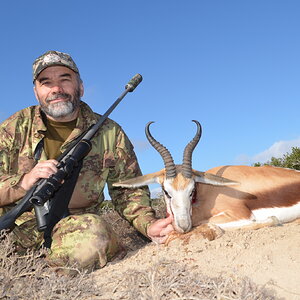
[0,0,300,197]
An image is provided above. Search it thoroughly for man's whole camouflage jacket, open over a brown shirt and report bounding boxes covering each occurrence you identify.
[0,102,154,235]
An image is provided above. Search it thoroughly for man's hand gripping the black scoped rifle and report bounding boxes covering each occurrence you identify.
[20,159,58,191]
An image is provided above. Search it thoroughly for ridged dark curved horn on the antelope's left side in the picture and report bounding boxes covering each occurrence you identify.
[145,122,176,178]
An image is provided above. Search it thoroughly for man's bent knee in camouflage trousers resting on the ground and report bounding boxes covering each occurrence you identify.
[46,214,126,271]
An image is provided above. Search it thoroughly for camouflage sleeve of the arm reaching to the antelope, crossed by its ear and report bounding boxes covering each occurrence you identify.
[107,130,155,236]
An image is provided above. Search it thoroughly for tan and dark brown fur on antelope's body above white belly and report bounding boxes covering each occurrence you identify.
[193,166,300,226]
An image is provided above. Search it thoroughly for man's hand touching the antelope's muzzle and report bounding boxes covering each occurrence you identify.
[147,215,174,244]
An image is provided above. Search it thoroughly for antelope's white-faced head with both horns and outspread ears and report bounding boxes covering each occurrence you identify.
[114,120,237,233]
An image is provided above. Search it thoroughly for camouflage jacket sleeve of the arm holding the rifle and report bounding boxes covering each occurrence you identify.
[0,123,26,207]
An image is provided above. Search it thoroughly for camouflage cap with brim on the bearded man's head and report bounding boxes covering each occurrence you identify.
[32,51,79,82]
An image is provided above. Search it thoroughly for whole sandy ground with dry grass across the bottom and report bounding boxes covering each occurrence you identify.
[0,211,300,300]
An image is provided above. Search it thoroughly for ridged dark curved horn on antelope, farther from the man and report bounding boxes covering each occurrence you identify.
[182,120,202,178]
